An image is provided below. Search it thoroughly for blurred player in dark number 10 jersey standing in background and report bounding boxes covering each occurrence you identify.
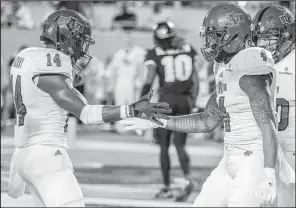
[142,21,199,201]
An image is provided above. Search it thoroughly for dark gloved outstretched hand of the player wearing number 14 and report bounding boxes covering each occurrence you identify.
[130,90,172,125]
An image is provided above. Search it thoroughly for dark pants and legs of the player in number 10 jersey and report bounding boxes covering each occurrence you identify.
[153,93,193,186]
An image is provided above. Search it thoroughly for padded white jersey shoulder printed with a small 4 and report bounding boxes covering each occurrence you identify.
[231,47,275,77]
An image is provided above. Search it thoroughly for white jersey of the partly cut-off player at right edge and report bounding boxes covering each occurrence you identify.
[276,50,295,151]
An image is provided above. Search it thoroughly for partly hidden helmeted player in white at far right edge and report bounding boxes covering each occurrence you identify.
[252,5,295,207]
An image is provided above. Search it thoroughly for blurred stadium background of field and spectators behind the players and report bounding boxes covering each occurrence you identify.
[1,1,295,207]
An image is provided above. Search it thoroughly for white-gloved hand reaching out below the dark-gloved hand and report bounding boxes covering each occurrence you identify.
[119,118,159,131]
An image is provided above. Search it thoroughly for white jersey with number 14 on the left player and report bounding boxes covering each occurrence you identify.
[10,48,73,148]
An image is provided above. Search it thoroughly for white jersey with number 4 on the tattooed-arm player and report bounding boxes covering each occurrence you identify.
[214,47,276,144]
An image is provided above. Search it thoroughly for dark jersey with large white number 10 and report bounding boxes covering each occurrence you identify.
[145,44,197,94]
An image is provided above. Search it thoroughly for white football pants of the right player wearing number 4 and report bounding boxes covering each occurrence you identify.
[193,144,264,207]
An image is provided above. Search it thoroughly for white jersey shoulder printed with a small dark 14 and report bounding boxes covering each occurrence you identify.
[21,48,73,79]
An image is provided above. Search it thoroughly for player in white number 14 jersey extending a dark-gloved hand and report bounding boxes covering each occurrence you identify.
[8,10,170,207]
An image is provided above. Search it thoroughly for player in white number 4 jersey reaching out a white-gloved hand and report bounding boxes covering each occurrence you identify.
[123,4,293,207]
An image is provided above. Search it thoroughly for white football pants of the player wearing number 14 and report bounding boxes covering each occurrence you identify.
[9,145,85,207]
